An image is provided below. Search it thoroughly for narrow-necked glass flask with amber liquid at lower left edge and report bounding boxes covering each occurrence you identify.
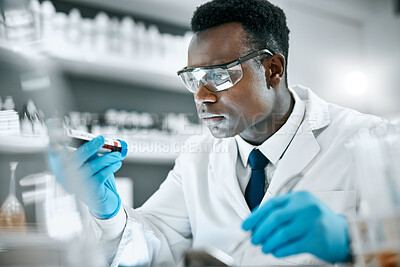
[0,162,26,231]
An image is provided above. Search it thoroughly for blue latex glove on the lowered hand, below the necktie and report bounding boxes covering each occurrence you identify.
[242,191,351,262]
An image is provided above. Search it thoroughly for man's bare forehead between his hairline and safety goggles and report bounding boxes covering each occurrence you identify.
[188,22,245,67]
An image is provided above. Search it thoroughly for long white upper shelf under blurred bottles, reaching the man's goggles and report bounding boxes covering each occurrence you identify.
[0,41,190,94]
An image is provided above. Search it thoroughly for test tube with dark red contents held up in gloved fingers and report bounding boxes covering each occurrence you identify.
[65,128,128,157]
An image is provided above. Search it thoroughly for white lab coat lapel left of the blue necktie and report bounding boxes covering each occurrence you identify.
[210,138,250,219]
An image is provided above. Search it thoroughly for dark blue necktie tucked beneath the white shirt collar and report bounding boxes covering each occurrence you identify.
[244,149,268,210]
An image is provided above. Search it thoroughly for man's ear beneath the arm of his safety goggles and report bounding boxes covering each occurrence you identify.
[262,53,285,89]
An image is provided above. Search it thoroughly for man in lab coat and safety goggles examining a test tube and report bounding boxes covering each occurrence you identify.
[53,0,379,266]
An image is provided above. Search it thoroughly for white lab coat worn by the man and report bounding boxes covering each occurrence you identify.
[98,86,381,266]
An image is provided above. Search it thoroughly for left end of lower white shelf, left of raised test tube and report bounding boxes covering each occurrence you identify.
[0,135,49,154]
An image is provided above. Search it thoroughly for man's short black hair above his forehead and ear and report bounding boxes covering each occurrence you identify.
[191,0,290,85]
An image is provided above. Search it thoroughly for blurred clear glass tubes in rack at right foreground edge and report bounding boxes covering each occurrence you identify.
[347,124,400,267]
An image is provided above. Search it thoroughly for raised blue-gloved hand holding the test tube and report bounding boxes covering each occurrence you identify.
[50,136,123,219]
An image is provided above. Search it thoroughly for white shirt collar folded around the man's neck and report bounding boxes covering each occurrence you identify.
[235,89,305,167]
